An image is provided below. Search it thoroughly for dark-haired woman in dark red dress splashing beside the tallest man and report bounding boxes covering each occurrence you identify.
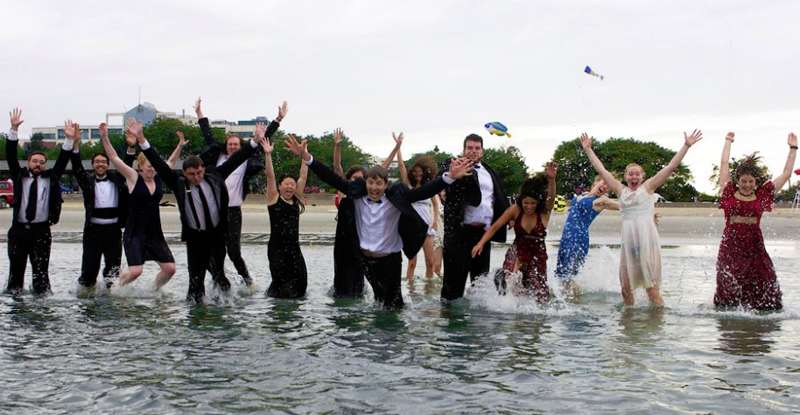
[472,162,558,304]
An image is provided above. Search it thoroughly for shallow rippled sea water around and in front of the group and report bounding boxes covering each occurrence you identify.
[0,242,800,414]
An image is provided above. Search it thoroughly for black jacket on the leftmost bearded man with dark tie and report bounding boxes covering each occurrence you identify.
[6,139,72,225]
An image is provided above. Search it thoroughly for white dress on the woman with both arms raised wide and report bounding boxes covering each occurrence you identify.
[619,186,661,289]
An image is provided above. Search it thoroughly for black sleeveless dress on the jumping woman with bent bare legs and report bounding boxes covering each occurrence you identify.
[122,176,175,267]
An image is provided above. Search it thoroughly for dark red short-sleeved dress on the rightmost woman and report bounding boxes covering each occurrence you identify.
[714,182,782,310]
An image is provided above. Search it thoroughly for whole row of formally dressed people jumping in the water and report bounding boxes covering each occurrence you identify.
[6,103,797,310]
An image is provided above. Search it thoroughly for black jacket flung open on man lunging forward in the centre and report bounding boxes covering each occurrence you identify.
[309,159,447,260]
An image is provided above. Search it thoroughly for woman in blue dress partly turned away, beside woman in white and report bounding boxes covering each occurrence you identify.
[556,176,619,295]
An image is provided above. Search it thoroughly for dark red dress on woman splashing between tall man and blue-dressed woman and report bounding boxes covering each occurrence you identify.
[495,212,550,303]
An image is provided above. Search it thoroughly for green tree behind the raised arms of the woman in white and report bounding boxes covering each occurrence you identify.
[553,138,698,201]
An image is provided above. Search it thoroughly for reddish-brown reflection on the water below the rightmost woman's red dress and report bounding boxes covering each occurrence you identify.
[717,318,781,356]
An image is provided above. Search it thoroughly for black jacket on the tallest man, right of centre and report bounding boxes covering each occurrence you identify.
[440,160,509,244]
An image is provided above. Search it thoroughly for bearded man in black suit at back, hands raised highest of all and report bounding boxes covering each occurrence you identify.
[194,98,288,286]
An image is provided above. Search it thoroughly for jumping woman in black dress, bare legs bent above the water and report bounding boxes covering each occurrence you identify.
[101,119,175,290]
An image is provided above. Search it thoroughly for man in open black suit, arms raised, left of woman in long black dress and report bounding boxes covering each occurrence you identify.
[131,118,266,303]
